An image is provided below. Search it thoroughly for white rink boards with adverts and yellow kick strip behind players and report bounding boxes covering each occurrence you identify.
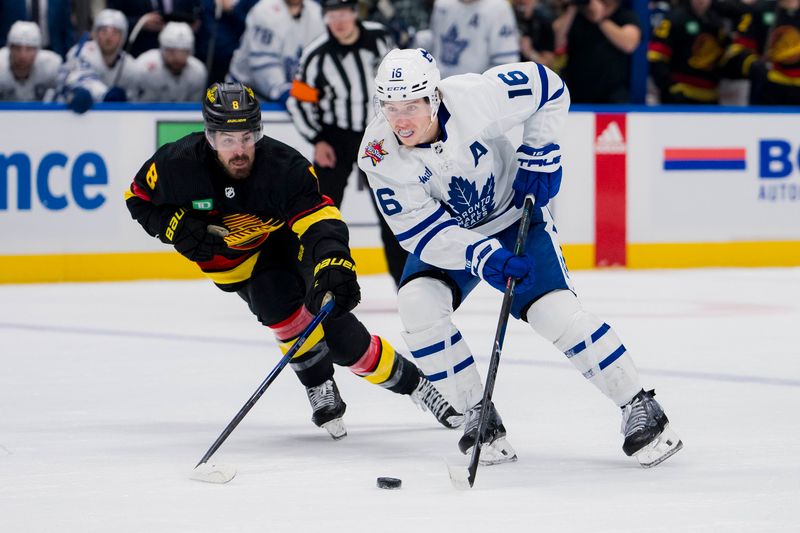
[0,104,800,282]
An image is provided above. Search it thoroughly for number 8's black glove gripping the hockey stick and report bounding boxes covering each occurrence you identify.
[306,257,361,317]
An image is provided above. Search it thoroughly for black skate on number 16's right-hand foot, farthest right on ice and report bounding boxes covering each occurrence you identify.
[622,390,683,468]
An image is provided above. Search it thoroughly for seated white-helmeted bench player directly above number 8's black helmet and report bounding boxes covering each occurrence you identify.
[136,22,208,102]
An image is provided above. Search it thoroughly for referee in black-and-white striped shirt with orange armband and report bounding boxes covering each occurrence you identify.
[286,0,407,284]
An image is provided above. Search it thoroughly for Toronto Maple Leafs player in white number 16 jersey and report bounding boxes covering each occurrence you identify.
[359,49,682,466]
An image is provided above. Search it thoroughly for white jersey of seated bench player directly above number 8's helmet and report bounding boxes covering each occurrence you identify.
[136,48,208,102]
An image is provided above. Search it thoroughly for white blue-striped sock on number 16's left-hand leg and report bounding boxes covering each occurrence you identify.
[398,277,483,413]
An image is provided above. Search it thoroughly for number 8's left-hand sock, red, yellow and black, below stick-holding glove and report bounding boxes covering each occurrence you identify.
[269,306,333,387]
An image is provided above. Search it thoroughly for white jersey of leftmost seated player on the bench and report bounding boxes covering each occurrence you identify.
[0,48,61,102]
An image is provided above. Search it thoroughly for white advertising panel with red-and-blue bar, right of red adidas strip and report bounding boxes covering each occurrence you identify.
[628,113,800,243]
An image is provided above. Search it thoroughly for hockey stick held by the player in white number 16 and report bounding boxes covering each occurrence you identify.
[447,195,533,489]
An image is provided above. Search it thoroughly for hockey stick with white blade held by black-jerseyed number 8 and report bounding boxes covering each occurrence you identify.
[191,293,334,483]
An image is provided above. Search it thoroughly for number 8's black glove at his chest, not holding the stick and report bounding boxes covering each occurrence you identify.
[158,208,226,263]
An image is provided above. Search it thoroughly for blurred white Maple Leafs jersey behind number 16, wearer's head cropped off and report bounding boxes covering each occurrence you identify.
[431,0,519,78]
